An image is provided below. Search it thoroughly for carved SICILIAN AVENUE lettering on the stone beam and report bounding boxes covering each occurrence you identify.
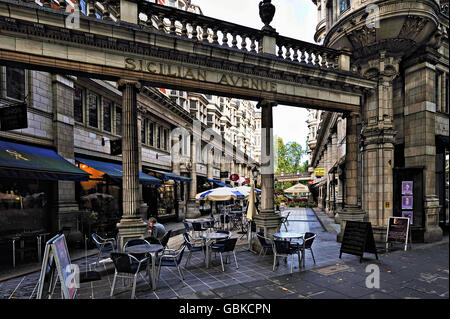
[125,58,277,92]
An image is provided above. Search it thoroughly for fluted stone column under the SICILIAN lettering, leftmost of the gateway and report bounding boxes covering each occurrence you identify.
[117,80,146,248]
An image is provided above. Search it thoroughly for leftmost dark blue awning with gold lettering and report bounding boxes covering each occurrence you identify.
[0,141,89,181]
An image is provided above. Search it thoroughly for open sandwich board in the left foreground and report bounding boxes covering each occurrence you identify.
[37,235,79,299]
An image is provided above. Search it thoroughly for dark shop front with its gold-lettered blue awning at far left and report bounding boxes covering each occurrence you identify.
[0,141,89,265]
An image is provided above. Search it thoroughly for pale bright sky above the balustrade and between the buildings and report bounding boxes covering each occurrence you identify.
[192,0,317,151]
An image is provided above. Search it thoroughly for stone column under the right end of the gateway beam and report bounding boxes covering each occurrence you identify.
[337,113,365,242]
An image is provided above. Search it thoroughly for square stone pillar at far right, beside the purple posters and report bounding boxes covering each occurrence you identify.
[404,48,443,242]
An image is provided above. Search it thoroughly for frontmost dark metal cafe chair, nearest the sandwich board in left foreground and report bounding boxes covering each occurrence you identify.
[110,252,148,299]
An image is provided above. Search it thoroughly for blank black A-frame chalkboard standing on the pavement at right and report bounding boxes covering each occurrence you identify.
[339,221,378,262]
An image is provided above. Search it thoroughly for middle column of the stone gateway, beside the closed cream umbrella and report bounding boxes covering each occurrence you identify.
[255,101,281,237]
